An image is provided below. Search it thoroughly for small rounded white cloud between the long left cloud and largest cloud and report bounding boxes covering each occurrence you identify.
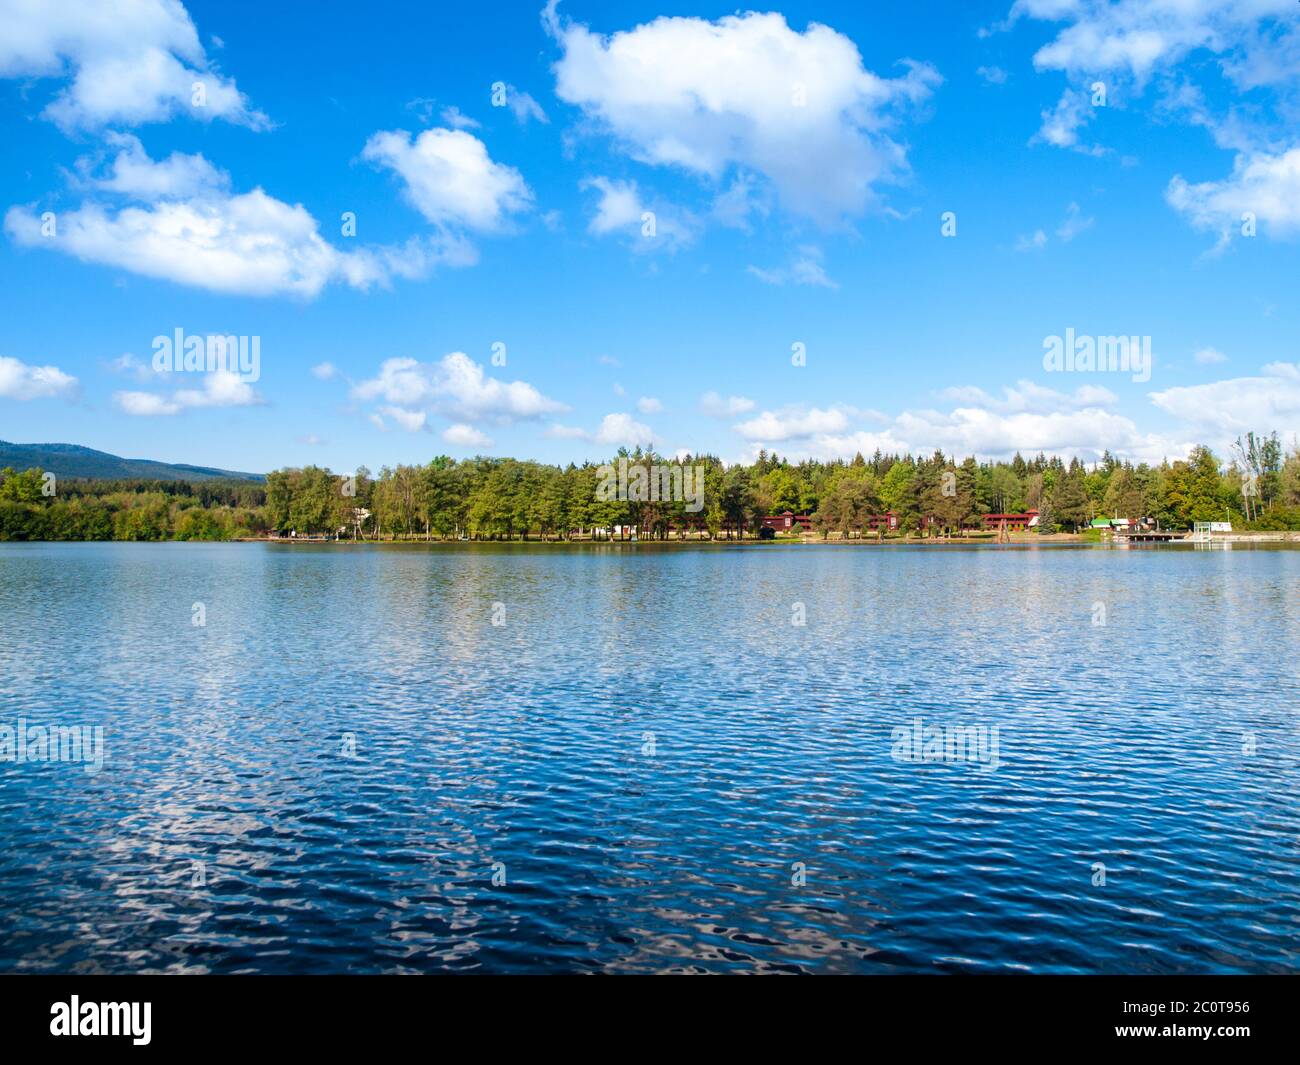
[361,129,533,233]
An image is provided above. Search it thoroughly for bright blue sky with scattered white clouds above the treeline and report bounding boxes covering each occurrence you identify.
[0,0,1300,472]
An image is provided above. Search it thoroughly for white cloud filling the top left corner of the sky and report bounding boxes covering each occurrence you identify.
[0,0,269,130]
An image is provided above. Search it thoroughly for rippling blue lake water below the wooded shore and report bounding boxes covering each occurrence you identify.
[0,544,1300,973]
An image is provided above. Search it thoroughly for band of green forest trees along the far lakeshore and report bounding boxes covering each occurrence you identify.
[0,433,1300,541]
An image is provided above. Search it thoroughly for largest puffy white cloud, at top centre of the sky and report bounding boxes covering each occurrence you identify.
[543,3,940,225]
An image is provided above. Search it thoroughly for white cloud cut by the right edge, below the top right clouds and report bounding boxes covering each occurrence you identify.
[1165,147,1300,242]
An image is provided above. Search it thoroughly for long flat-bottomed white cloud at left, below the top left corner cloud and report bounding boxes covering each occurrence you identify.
[4,138,460,299]
